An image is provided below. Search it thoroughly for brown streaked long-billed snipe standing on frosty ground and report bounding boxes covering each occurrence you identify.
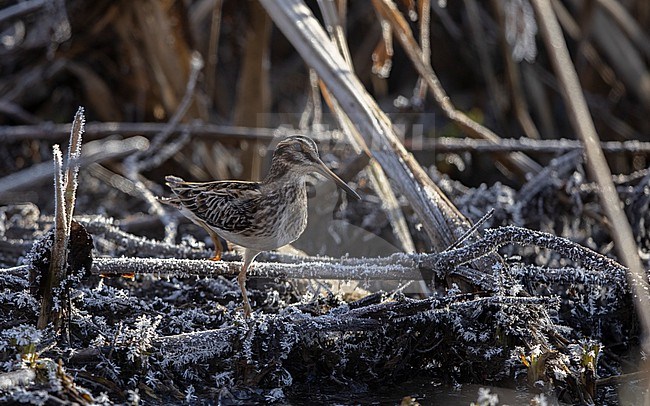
[163,136,359,317]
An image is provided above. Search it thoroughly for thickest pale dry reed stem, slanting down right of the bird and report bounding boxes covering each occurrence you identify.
[262,0,492,260]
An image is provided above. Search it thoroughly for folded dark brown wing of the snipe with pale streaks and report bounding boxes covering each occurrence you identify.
[166,177,261,233]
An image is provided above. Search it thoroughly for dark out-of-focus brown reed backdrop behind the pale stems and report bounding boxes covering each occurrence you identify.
[0,0,650,170]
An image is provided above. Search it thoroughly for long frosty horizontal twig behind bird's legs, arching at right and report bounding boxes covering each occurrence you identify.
[86,226,625,289]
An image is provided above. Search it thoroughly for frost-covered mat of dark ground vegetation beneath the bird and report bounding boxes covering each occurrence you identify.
[0,143,648,403]
